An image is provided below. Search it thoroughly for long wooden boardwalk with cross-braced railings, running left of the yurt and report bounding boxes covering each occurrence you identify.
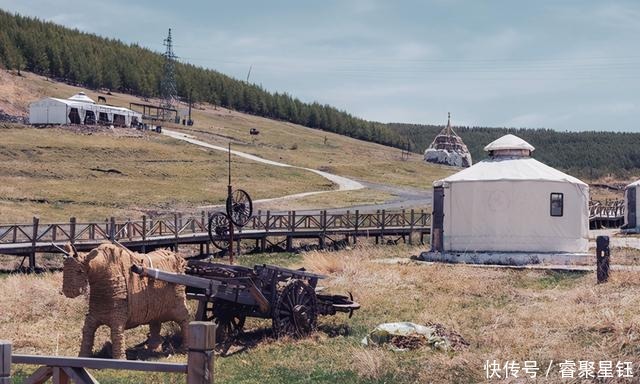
[0,210,431,268]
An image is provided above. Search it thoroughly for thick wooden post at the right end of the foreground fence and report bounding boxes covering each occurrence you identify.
[187,321,216,384]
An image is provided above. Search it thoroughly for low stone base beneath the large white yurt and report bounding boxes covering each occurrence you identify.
[419,252,595,265]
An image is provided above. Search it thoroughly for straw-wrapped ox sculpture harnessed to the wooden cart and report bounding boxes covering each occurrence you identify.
[62,244,189,359]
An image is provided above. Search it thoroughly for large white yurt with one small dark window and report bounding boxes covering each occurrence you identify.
[431,135,589,253]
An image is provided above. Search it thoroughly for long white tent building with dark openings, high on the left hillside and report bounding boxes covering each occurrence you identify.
[29,92,142,127]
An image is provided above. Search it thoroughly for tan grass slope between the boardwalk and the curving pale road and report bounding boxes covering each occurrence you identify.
[0,125,333,223]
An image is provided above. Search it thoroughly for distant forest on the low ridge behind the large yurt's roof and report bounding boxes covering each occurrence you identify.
[387,124,640,178]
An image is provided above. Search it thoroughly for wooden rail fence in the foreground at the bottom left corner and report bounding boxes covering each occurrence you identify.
[0,321,215,384]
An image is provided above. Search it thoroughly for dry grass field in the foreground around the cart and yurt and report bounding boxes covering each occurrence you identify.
[0,246,640,383]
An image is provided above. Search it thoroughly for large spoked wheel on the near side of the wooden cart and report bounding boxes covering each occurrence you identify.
[272,280,318,338]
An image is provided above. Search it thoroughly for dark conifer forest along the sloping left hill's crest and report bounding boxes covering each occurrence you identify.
[0,10,404,147]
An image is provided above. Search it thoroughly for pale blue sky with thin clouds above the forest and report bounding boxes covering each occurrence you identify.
[0,0,640,132]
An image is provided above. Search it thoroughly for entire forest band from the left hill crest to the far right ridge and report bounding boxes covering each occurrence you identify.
[0,10,640,177]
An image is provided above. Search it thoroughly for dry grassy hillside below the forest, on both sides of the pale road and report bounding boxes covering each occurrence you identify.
[0,71,455,223]
